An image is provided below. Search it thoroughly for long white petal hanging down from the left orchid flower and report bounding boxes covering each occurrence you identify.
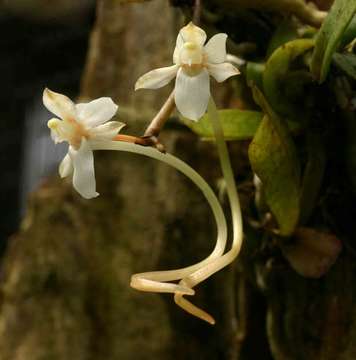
[69,138,99,199]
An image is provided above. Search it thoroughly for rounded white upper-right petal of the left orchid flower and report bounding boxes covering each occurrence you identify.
[76,97,118,128]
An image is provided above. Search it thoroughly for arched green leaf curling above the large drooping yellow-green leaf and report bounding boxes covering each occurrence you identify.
[263,39,314,117]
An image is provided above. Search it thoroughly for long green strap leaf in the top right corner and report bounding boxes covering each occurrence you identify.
[311,0,356,83]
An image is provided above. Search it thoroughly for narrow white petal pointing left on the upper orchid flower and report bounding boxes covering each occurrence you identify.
[135,65,178,90]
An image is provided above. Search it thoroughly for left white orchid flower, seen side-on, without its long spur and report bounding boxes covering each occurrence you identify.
[43,89,125,199]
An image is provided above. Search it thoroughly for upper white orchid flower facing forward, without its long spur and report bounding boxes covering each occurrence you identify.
[135,22,240,121]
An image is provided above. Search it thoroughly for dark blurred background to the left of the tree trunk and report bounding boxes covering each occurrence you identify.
[0,0,95,254]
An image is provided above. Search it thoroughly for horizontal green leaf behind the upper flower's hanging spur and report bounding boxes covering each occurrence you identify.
[182,109,262,140]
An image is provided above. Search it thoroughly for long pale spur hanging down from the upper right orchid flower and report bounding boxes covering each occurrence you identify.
[174,98,243,324]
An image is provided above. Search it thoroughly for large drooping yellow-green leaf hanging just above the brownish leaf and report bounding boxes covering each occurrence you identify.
[248,87,300,236]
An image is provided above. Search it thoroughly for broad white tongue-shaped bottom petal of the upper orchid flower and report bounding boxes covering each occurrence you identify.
[174,69,210,120]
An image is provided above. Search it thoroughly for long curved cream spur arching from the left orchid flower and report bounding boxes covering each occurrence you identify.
[91,141,227,295]
